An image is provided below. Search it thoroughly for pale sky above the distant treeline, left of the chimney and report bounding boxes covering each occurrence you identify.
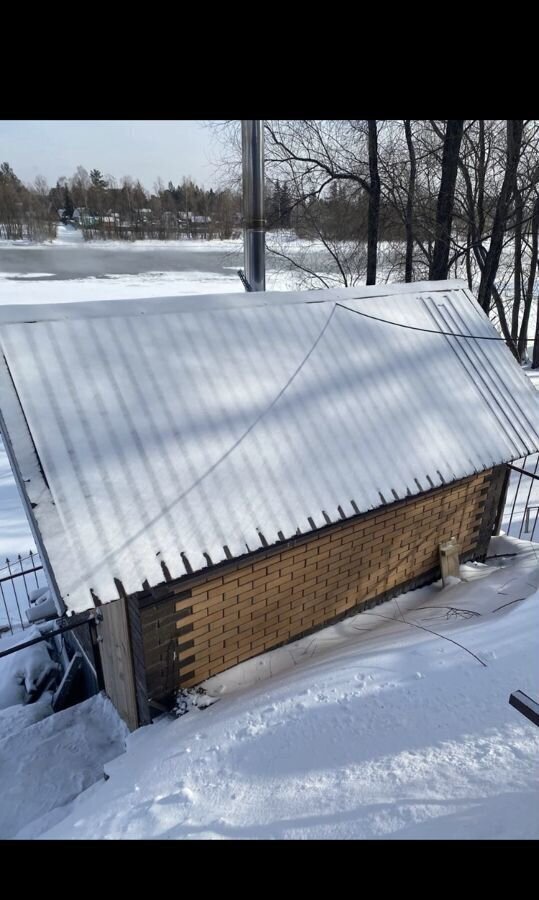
[0,119,225,189]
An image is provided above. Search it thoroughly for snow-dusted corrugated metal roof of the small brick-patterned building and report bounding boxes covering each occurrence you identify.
[0,282,539,610]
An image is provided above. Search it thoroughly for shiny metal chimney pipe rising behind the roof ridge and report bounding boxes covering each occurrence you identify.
[241,119,266,291]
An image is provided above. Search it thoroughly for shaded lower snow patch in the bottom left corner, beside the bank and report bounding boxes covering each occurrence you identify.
[0,625,128,839]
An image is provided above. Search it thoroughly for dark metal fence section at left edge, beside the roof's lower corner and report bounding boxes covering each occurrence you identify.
[0,550,47,637]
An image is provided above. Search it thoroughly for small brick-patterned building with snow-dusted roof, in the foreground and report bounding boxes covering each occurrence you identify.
[0,282,539,728]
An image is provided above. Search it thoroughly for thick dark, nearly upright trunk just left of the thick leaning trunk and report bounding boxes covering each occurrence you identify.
[429,119,464,281]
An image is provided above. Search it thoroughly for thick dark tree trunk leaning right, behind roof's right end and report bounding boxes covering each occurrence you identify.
[477,119,524,315]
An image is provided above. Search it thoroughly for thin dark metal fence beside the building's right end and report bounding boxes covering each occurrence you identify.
[502,453,539,541]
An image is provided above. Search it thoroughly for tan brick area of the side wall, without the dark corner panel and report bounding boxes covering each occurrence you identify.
[141,472,498,687]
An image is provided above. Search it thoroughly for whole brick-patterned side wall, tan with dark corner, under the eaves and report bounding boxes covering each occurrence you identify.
[140,467,504,699]
